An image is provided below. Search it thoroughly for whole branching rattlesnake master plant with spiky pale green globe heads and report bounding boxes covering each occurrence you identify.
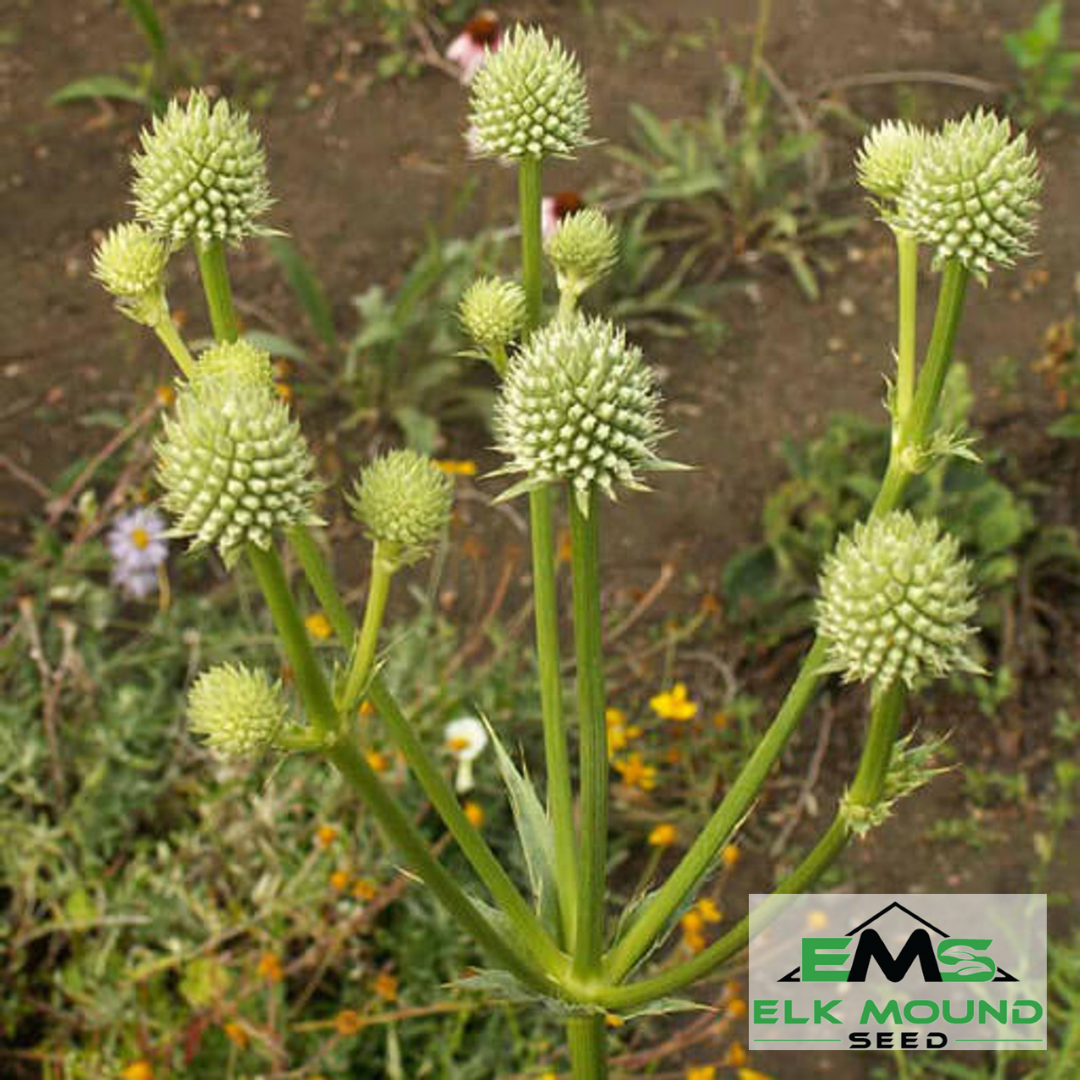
[95,28,1038,1080]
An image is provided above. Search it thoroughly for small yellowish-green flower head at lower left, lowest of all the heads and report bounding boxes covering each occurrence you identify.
[188,664,288,758]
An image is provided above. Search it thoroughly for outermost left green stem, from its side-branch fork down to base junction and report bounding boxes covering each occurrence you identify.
[326,740,558,995]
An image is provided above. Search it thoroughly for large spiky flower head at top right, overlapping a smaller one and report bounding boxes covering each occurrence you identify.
[900,109,1042,276]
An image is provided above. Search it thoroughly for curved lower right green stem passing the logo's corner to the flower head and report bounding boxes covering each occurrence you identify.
[596,684,907,1010]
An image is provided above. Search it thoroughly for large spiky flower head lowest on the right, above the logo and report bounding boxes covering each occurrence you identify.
[818,512,980,689]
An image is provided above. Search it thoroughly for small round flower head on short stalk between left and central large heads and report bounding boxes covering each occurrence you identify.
[349,450,454,566]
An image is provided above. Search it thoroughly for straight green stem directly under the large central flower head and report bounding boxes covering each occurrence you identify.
[569,487,608,981]
